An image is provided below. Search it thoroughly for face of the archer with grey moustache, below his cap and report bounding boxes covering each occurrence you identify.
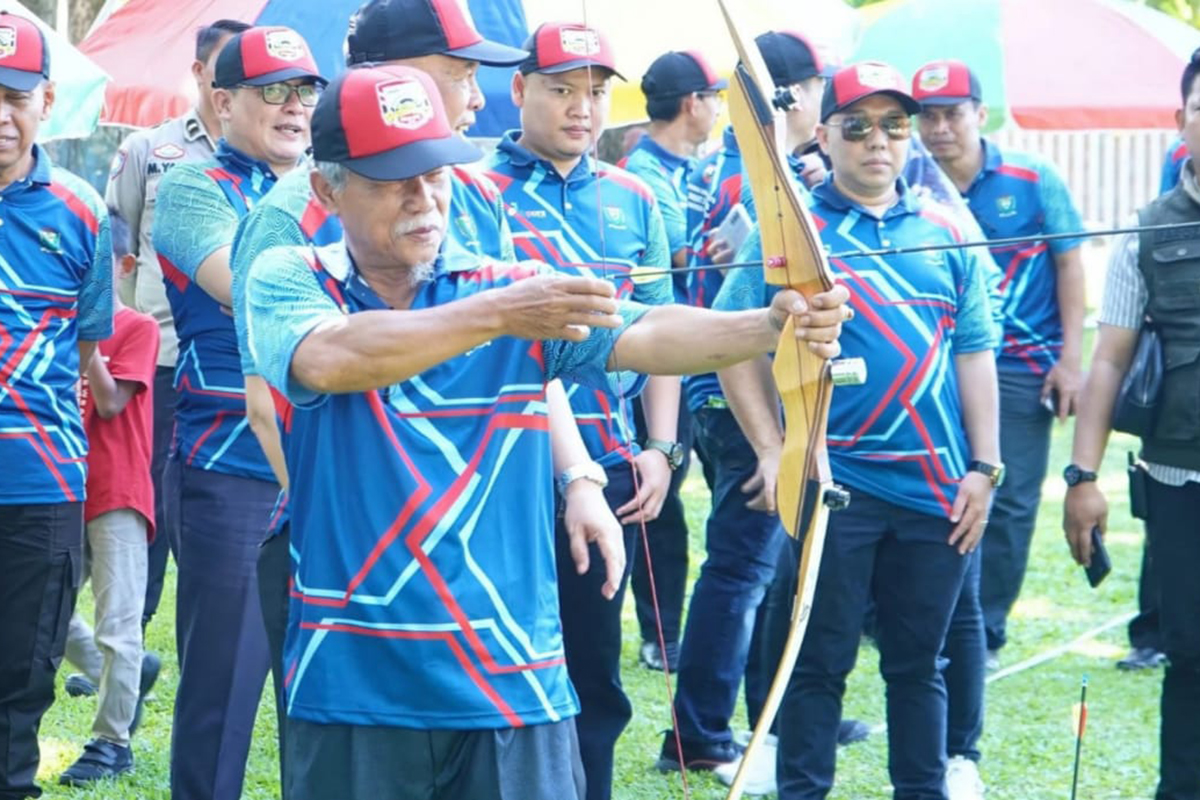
[322,167,451,269]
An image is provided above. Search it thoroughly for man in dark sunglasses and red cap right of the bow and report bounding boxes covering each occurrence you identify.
[714,62,1002,800]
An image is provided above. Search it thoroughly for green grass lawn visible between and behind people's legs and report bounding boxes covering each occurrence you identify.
[40,425,1162,800]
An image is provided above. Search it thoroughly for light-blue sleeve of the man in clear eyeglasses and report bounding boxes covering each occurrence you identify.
[154,164,239,281]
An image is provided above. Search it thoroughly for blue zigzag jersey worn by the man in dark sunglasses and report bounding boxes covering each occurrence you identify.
[713,179,995,518]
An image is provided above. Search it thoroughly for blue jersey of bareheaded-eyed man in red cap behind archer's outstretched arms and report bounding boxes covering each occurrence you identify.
[488,132,672,467]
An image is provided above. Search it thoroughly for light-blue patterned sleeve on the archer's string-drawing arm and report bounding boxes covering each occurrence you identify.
[245,247,344,407]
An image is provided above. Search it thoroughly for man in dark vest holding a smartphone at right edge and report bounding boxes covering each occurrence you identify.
[1063,50,1200,800]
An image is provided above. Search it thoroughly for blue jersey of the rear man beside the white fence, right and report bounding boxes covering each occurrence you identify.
[962,142,1082,374]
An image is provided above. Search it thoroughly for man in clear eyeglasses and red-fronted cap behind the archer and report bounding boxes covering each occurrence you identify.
[154,28,325,800]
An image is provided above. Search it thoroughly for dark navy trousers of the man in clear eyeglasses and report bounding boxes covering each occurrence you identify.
[163,458,280,800]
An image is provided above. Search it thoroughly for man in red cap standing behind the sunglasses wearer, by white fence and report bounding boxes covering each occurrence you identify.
[912,61,1085,690]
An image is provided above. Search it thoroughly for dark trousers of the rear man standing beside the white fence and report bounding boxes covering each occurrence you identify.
[979,372,1054,650]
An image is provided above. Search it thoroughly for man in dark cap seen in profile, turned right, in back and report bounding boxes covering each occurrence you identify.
[620,50,728,672]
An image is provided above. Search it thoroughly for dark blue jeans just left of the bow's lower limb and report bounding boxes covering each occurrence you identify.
[674,408,787,746]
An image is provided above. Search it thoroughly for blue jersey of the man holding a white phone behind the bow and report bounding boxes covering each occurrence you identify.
[683,126,742,411]
